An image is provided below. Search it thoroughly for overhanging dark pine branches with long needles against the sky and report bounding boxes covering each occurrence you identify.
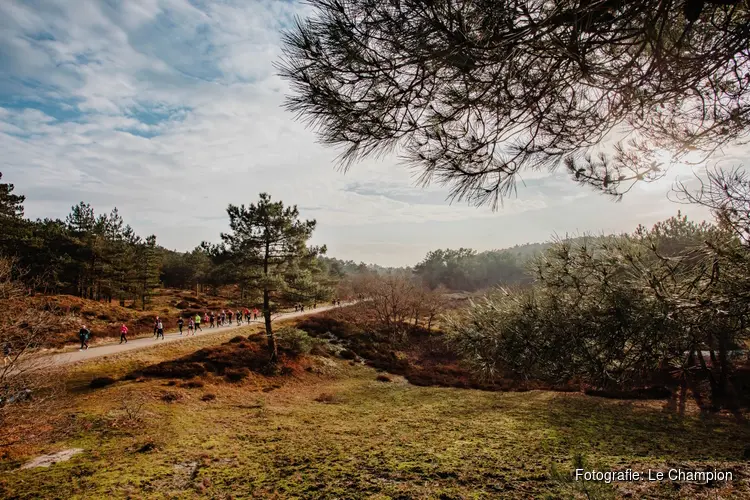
[278,0,750,208]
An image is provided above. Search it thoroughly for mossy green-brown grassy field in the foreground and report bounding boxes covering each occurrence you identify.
[0,322,750,499]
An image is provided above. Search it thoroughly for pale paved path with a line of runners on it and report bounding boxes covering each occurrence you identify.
[37,303,350,366]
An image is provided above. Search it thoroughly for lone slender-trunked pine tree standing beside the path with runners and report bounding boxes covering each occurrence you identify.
[210,193,326,362]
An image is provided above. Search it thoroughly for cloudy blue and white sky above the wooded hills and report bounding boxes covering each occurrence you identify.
[0,0,742,266]
